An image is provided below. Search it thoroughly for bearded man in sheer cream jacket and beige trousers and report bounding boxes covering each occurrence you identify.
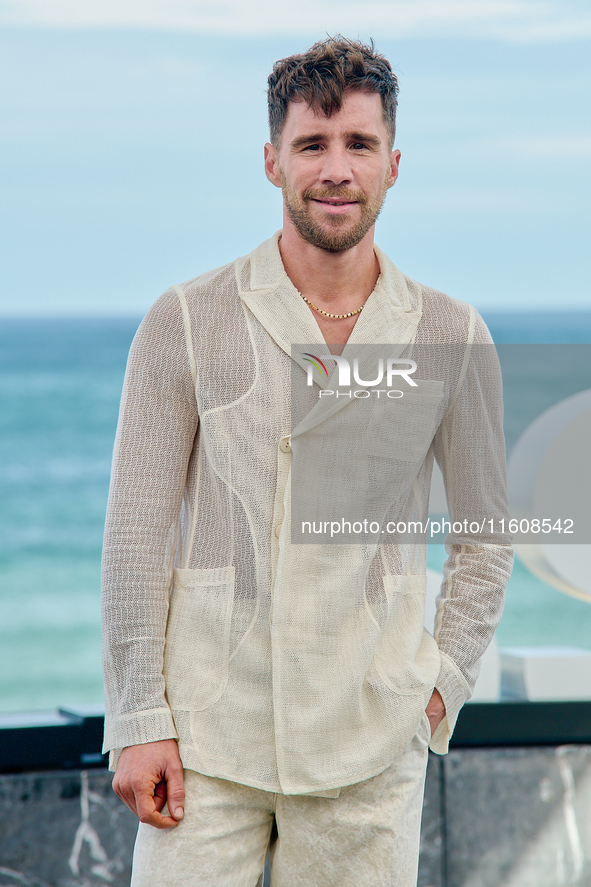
[103,38,511,887]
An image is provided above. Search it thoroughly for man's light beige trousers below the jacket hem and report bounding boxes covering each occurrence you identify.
[131,718,428,887]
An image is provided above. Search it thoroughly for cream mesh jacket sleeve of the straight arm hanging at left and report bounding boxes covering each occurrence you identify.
[102,291,198,767]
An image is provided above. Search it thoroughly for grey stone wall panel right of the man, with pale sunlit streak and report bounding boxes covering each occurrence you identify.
[442,745,591,887]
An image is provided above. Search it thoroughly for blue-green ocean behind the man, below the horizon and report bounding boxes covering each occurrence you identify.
[0,312,591,712]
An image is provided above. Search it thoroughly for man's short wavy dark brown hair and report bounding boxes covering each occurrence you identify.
[267,34,398,147]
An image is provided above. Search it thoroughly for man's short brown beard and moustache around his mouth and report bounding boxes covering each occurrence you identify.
[281,174,388,253]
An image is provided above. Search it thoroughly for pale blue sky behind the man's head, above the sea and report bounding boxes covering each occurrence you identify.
[0,0,591,315]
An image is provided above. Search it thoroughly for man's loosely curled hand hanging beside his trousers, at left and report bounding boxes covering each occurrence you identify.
[113,739,185,828]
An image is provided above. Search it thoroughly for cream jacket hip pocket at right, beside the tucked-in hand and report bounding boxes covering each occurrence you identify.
[374,575,440,695]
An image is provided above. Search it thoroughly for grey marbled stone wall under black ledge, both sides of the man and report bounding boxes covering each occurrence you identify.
[0,745,591,887]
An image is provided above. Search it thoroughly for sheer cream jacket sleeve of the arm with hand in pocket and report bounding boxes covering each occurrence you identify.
[431,315,513,754]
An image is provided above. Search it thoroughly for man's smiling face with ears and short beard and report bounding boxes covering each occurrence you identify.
[265,90,400,252]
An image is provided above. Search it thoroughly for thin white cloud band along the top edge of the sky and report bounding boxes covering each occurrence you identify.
[0,0,591,42]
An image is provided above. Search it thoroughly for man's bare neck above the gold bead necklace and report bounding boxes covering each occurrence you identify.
[279,218,380,313]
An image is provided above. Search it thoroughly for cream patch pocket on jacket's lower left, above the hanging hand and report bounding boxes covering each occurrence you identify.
[164,567,235,711]
